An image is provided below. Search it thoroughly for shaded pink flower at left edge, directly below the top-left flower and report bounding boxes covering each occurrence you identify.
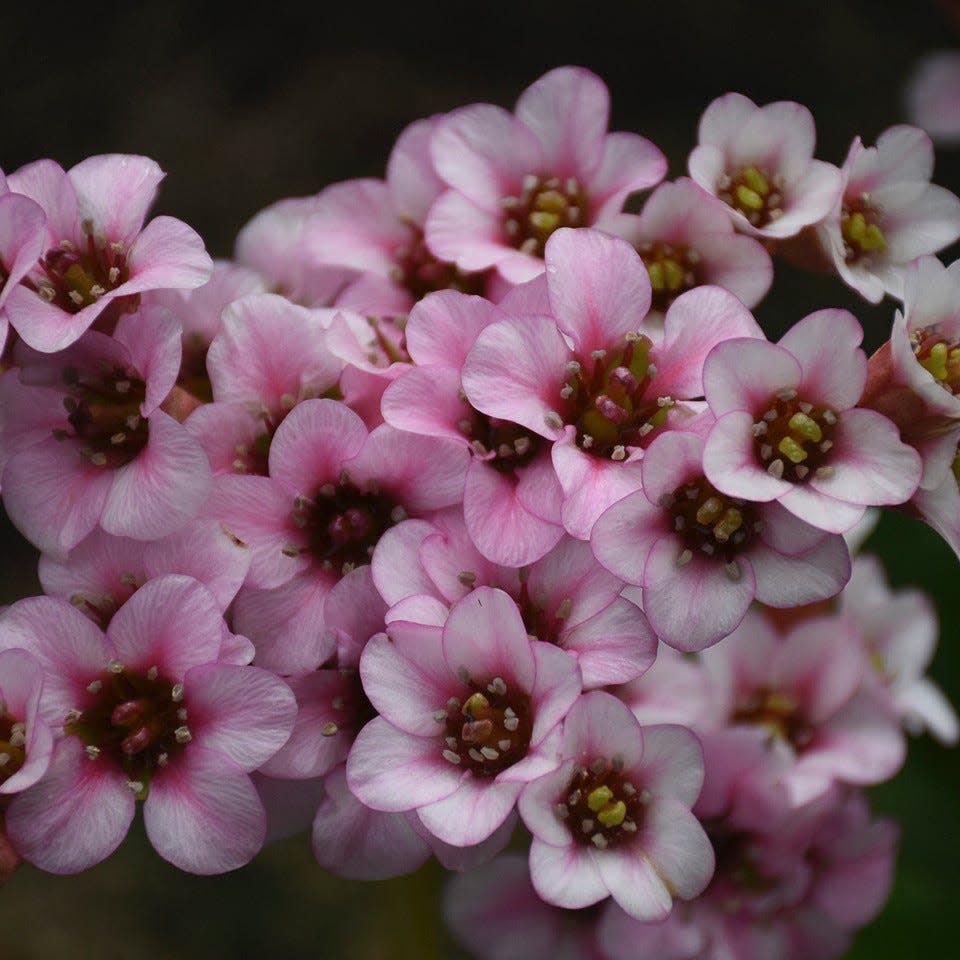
[0,306,210,556]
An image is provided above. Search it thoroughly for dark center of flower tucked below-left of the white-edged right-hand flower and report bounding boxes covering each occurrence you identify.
[660,477,760,577]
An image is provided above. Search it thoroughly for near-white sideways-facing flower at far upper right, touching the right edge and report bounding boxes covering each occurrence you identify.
[817,125,960,303]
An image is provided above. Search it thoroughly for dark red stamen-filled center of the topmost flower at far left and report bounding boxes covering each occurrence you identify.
[36,222,130,313]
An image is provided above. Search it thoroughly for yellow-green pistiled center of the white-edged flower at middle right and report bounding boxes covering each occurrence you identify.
[753,388,837,483]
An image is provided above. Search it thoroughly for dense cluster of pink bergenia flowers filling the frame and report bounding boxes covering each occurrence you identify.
[0,67,960,960]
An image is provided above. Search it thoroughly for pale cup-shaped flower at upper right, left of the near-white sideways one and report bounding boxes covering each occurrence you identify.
[689,93,840,240]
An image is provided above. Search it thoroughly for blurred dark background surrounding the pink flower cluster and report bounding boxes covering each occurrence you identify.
[0,0,960,960]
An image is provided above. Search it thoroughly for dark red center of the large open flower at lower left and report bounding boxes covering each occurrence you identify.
[64,661,191,800]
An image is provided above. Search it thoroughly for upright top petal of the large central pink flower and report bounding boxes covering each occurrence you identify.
[544,227,650,356]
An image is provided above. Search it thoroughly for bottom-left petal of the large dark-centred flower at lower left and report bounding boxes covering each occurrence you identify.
[6,737,136,874]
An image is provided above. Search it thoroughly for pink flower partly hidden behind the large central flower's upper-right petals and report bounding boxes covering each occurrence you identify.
[604,177,773,340]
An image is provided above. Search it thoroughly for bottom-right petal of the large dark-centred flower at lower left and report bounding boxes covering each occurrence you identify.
[143,745,267,875]
